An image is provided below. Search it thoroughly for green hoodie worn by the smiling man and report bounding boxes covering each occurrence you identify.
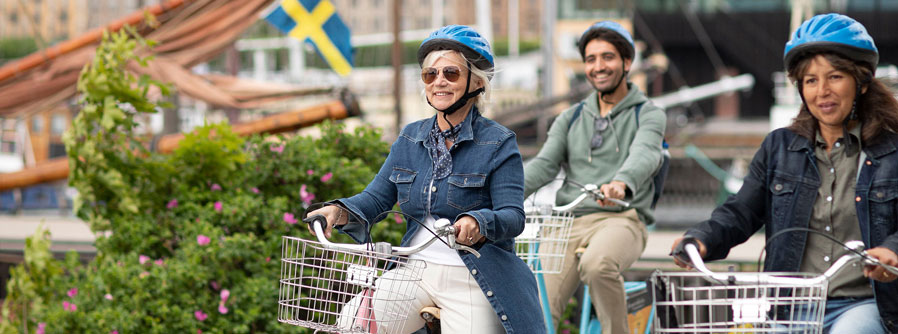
[524,82,667,224]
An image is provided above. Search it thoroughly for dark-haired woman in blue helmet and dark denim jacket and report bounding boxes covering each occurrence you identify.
[674,14,898,334]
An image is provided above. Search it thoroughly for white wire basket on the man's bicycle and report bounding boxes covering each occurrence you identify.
[515,206,574,274]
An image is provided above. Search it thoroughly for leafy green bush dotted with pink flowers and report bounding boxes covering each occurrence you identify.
[0,26,403,333]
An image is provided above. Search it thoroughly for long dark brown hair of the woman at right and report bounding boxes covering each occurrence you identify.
[788,52,898,145]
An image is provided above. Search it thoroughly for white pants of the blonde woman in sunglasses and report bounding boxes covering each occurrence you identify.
[343,263,505,334]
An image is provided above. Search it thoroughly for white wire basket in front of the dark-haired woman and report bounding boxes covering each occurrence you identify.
[652,271,827,334]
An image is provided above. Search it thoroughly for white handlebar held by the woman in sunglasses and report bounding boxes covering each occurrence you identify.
[302,215,480,258]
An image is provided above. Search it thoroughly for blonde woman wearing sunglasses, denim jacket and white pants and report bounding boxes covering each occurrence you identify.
[310,26,545,333]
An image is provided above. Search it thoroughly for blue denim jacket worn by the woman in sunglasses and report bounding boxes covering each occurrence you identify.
[339,109,545,333]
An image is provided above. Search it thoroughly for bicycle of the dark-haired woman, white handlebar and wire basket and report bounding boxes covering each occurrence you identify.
[652,238,898,333]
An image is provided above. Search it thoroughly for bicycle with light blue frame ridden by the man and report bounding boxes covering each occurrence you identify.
[515,180,653,334]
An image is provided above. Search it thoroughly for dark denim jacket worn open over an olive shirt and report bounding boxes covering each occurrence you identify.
[686,129,898,332]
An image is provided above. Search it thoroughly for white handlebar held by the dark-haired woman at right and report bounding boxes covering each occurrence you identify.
[672,237,898,285]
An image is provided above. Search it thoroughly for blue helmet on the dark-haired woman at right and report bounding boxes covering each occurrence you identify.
[783,13,879,71]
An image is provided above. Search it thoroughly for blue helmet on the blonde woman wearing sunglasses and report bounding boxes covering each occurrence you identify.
[418,25,495,72]
